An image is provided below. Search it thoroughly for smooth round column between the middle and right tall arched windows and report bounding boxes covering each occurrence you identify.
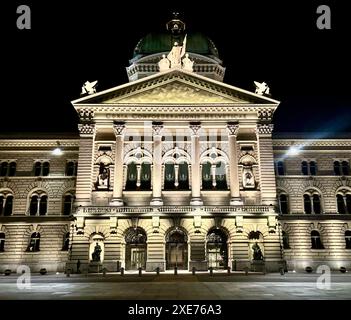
[190,123,203,206]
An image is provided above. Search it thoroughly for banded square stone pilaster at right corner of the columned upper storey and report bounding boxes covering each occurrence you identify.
[256,124,277,206]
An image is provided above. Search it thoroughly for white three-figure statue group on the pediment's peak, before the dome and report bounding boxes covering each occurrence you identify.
[158,35,194,72]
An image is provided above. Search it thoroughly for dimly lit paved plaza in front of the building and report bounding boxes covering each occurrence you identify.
[0,273,351,300]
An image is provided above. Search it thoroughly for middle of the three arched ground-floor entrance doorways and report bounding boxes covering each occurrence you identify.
[166,228,188,270]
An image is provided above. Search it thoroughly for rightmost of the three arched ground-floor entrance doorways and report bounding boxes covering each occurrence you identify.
[206,228,228,269]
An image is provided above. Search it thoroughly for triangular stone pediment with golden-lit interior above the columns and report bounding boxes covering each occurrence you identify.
[72,70,279,105]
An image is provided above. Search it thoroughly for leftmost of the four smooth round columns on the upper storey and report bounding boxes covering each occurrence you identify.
[110,122,125,206]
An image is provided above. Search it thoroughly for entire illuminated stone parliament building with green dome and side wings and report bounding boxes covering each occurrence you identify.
[0,19,351,272]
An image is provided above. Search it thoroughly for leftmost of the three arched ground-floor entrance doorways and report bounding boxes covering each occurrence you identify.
[125,227,147,270]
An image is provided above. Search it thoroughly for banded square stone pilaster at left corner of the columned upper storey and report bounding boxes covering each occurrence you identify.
[76,123,96,206]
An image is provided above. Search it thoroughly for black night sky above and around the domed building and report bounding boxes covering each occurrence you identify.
[0,0,351,136]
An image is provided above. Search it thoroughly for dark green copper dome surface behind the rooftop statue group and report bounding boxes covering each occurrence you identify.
[134,32,218,58]
